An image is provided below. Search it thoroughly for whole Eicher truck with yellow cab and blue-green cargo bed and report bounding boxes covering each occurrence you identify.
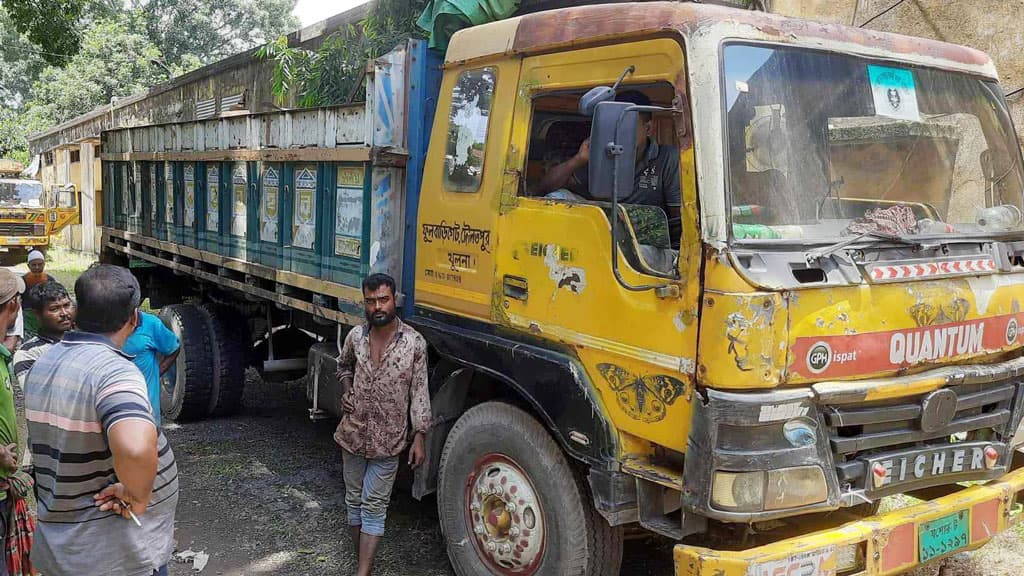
[102,2,1024,576]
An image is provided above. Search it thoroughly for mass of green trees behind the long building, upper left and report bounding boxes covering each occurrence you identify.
[0,0,299,161]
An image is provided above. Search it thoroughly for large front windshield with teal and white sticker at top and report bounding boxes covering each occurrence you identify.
[723,44,1024,242]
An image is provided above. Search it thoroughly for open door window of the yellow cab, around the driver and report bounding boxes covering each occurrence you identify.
[520,84,680,276]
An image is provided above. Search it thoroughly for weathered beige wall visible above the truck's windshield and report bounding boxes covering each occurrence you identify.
[771,0,1024,141]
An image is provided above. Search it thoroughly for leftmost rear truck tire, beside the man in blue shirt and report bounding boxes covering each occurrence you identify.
[160,304,213,421]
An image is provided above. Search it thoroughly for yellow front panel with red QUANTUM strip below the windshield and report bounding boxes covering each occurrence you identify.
[785,274,1024,384]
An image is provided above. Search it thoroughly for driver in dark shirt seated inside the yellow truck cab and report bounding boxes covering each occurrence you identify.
[537,90,682,248]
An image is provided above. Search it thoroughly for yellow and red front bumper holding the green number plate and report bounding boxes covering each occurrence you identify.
[674,461,1024,576]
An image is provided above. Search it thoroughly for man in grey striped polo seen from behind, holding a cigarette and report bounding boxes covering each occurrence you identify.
[26,264,178,576]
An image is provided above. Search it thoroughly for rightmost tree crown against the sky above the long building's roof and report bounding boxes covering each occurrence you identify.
[132,0,299,66]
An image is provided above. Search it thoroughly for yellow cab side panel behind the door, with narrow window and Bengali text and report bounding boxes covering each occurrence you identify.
[416,58,521,322]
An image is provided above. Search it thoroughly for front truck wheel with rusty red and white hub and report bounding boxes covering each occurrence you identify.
[437,402,623,576]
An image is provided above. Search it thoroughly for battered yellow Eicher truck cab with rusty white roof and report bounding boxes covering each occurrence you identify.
[411,3,1024,575]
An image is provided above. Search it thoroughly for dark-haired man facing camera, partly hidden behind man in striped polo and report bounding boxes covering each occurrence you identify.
[14,282,75,465]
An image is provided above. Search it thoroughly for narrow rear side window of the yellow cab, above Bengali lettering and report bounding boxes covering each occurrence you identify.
[444,68,498,193]
